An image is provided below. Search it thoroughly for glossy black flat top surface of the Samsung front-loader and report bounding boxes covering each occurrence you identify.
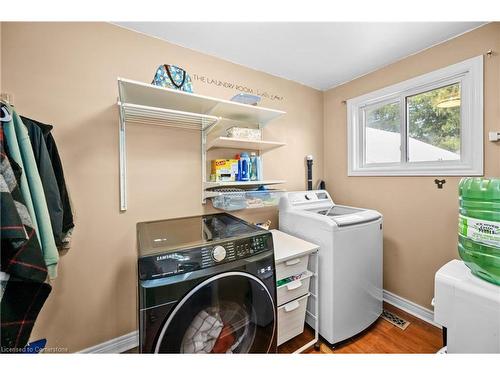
[137,213,267,256]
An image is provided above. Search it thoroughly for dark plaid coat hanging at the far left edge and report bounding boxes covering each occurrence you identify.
[0,116,51,353]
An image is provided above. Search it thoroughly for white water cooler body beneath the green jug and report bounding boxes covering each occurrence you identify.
[434,260,500,353]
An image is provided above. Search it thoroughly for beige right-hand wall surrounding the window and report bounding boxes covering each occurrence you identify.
[324,23,500,308]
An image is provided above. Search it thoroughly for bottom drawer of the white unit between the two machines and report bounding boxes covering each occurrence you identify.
[278,293,309,345]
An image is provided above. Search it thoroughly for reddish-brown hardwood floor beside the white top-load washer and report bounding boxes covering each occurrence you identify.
[278,303,443,354]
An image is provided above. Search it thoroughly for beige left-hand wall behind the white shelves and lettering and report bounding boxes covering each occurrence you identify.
[1,23,323,351]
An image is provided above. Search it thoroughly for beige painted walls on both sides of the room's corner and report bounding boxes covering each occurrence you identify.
[0,22,500,351]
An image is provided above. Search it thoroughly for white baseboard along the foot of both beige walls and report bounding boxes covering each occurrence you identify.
[75,290,441,354]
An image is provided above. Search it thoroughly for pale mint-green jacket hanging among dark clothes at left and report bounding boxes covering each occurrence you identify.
[5,109,59,279]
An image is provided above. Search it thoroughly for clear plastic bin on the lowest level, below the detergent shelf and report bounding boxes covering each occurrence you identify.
[212,190,282,211]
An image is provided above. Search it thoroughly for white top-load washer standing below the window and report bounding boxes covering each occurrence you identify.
[279,190,383,344]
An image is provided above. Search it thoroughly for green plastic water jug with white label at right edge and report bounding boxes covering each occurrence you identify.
[458,177,500,285]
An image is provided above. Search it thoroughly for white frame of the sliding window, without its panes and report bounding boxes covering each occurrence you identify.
[347,56,484,176]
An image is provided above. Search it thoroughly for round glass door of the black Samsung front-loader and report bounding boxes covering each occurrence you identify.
[155,272,276,353]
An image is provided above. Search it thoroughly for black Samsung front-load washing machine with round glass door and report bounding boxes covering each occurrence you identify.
[137,213,277,353]
